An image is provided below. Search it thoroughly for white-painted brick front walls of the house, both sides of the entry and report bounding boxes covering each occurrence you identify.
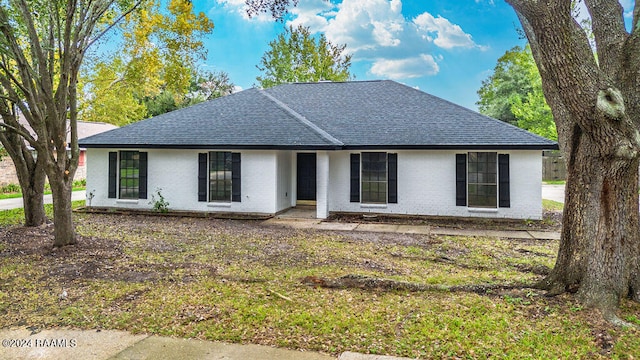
[87,149,542,219]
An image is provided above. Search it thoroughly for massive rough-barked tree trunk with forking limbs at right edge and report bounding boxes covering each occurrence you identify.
[507,0,640,314]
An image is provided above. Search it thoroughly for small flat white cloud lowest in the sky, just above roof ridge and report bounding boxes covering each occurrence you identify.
[371,54,440,80]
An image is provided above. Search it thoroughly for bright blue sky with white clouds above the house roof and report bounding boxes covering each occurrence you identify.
[194,0,631,110]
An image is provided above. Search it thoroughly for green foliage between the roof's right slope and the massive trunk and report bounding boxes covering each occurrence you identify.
[477,45,558,140]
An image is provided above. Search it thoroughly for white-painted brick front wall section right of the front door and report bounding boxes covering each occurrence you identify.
[329,150,542,219]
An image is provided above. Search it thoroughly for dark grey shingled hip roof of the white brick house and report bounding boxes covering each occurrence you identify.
[80,80,557,149]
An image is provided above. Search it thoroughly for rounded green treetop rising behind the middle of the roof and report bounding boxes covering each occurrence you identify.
[256,26,352,88]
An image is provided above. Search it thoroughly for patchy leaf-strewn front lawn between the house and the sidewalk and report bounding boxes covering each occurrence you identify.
[0,214,640,359]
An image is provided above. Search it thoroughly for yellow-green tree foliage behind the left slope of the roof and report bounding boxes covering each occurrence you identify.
[81,0,220,126]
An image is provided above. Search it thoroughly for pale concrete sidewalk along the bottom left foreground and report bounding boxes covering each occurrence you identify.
[0,328,406,360]
